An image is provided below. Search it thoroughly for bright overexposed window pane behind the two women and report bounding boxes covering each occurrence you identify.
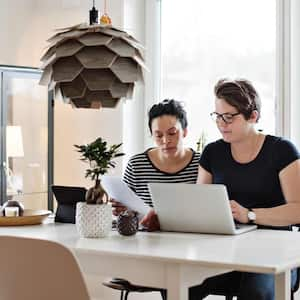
[161,0,276,148]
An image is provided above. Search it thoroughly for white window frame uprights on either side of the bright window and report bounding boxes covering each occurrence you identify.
[144,0,291,148]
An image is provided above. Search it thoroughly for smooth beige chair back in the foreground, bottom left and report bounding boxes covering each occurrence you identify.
[0,236,90,300]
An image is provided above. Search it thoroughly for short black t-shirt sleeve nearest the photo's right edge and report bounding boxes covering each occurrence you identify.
[276,139,300,172]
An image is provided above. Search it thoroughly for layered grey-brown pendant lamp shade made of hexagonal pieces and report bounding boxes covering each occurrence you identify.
[40,24,146,108]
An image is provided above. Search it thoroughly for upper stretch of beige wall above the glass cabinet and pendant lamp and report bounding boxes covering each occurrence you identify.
[0,0,123,67]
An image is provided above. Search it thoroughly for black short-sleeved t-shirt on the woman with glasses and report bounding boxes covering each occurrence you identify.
[199,135,300,208]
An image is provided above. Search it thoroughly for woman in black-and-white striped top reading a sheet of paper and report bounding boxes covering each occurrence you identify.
[113,99,200,230]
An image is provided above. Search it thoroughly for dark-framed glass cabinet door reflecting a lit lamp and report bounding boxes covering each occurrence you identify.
[0,66,53,209]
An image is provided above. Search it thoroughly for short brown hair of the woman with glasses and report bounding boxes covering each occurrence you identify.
[214,79,261,121]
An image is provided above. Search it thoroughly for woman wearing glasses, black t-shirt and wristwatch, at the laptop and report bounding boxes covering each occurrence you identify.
[190,80,300,300]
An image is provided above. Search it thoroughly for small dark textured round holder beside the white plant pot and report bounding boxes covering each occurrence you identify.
[117,210,139,235]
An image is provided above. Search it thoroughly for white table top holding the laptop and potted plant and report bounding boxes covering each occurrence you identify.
[0,223,300,273]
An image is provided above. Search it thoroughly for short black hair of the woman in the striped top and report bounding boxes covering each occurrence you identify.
[148,99,188,134]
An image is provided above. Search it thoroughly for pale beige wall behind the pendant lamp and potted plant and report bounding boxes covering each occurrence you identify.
[0,0,124,186]
